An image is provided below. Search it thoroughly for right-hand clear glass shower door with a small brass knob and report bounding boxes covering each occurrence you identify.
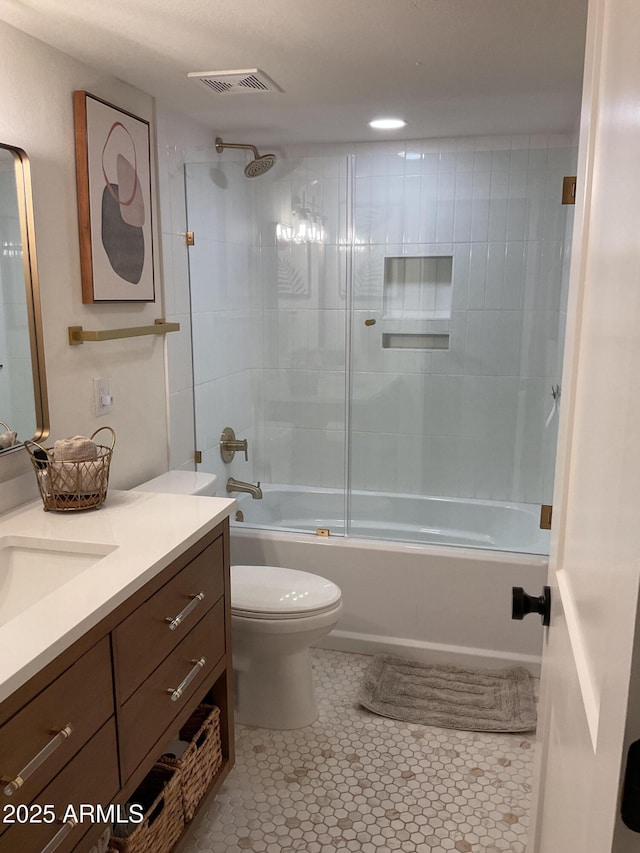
[348,135,575,553]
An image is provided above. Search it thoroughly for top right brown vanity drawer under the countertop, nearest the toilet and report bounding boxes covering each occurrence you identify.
[113,536,224,703]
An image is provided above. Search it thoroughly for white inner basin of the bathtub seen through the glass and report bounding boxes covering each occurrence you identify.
[236,484,549,554]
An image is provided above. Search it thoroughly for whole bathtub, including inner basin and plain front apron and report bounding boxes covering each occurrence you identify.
[231,485,549,674]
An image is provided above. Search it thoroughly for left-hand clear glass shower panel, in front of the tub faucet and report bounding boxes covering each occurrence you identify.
[186,154,346,535]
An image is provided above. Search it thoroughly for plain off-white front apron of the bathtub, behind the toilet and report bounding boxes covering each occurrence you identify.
[231,488,547,674]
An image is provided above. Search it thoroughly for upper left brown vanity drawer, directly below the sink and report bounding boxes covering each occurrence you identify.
[0,637,114,833]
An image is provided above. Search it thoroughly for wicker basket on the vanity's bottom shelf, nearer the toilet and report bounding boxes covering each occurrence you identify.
[160,705,222,822]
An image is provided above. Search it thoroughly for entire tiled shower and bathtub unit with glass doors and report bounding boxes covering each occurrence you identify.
[185,140,575,684]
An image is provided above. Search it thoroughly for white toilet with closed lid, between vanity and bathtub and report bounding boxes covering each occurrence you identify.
[135,471,342,729]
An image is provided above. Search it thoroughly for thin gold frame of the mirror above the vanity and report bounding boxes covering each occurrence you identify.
[0,143,49,452]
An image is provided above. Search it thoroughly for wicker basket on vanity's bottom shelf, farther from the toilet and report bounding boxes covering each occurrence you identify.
[109,764,184,853]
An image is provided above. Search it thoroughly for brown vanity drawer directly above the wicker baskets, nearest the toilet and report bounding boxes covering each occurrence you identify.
[119,601,225,784]
